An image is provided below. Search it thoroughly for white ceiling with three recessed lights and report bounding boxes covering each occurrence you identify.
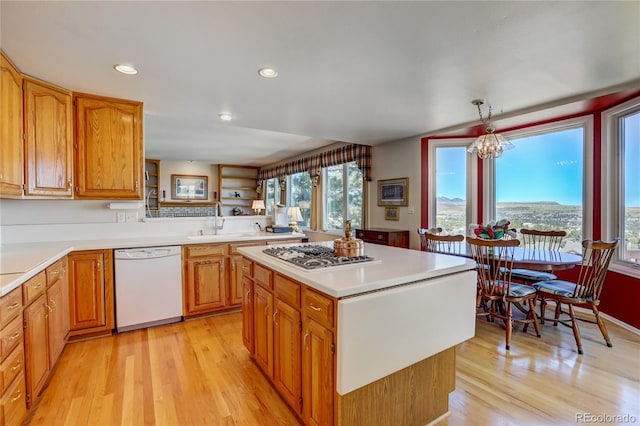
[0,0,640,165]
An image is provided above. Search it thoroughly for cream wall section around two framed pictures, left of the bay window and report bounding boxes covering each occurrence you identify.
[368,137,422,249]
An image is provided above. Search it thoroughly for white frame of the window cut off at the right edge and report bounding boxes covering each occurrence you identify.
[600,97,640,278]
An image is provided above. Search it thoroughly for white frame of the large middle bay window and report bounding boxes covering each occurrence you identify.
[482,115,594,246]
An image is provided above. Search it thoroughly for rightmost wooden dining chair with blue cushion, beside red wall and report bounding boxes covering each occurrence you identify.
[533,238,619,355]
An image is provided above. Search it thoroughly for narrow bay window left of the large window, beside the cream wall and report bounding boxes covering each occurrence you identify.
[429,139,478,235]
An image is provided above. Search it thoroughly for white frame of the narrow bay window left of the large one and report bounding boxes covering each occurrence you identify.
[427,138,478,233]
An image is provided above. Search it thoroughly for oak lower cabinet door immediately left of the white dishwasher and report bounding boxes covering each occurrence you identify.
[69,251,107,330]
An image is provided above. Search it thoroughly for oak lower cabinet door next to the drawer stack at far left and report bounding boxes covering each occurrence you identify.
[23,294,49,407]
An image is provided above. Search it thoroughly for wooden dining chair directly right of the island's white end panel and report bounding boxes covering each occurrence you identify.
[467,237,540,350]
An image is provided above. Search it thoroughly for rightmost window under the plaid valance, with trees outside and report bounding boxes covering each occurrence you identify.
[322,162,363,231]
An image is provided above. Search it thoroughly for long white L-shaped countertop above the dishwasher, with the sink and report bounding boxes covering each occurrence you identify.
[0,232,305,296]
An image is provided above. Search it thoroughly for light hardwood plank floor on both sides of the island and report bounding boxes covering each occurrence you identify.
[27,313,640,426]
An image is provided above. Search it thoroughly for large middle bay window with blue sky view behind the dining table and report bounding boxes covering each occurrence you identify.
[487,122,586,253]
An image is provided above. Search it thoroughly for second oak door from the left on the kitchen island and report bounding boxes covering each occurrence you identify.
[253,285,273,378]
